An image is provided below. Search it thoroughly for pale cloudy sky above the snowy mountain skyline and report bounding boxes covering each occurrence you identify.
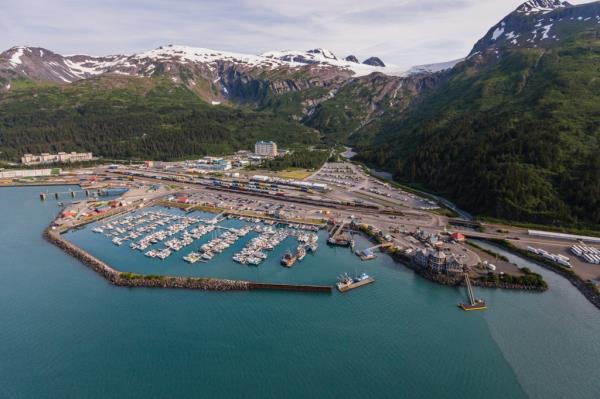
[0,0,582,66]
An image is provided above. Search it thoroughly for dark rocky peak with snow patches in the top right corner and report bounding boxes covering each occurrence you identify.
[469,0,600,57]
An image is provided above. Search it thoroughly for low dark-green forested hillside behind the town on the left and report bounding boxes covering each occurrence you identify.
[0,75,319,160]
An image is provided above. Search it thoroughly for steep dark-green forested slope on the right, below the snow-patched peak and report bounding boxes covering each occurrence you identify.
[360,26,600,225]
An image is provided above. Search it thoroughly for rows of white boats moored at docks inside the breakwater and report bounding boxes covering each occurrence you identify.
[66,207,319,276]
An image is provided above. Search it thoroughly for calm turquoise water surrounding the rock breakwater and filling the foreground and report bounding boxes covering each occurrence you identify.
[0,188,600,398]
